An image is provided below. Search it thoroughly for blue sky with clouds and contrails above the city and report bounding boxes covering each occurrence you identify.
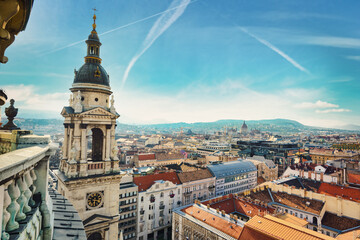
[0,0,360,127]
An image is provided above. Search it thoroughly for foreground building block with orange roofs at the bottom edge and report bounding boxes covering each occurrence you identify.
[172,197,334,240]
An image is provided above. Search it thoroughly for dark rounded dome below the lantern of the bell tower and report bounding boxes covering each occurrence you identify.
[74,62,110,87]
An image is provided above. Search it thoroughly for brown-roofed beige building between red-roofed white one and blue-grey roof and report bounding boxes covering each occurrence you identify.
[177,169,215,205]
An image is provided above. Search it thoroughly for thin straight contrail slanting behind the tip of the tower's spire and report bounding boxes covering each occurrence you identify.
[40,0,198,56]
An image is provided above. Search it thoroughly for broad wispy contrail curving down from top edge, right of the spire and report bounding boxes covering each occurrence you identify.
[121,0,190,89]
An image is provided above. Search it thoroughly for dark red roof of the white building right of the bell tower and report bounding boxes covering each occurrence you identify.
[134,172,181,192]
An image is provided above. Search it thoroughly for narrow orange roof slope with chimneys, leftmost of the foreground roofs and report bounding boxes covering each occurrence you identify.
[181,205,242,239]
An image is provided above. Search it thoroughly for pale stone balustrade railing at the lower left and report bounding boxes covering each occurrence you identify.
[0,146,52,239]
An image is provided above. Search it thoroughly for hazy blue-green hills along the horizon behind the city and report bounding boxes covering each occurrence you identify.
[7,119,354,135]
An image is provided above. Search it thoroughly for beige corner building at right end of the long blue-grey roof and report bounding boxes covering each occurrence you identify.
[246,156,278,181]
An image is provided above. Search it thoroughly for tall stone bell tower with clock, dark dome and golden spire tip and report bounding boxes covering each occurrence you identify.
[56,14,121,240]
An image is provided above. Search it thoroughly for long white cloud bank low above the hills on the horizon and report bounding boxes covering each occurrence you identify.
[2,79,360,127]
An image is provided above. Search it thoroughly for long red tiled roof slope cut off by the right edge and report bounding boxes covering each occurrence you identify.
[318,183,360,202]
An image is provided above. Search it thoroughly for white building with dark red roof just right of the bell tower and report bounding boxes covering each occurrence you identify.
[134,172,182,240]
